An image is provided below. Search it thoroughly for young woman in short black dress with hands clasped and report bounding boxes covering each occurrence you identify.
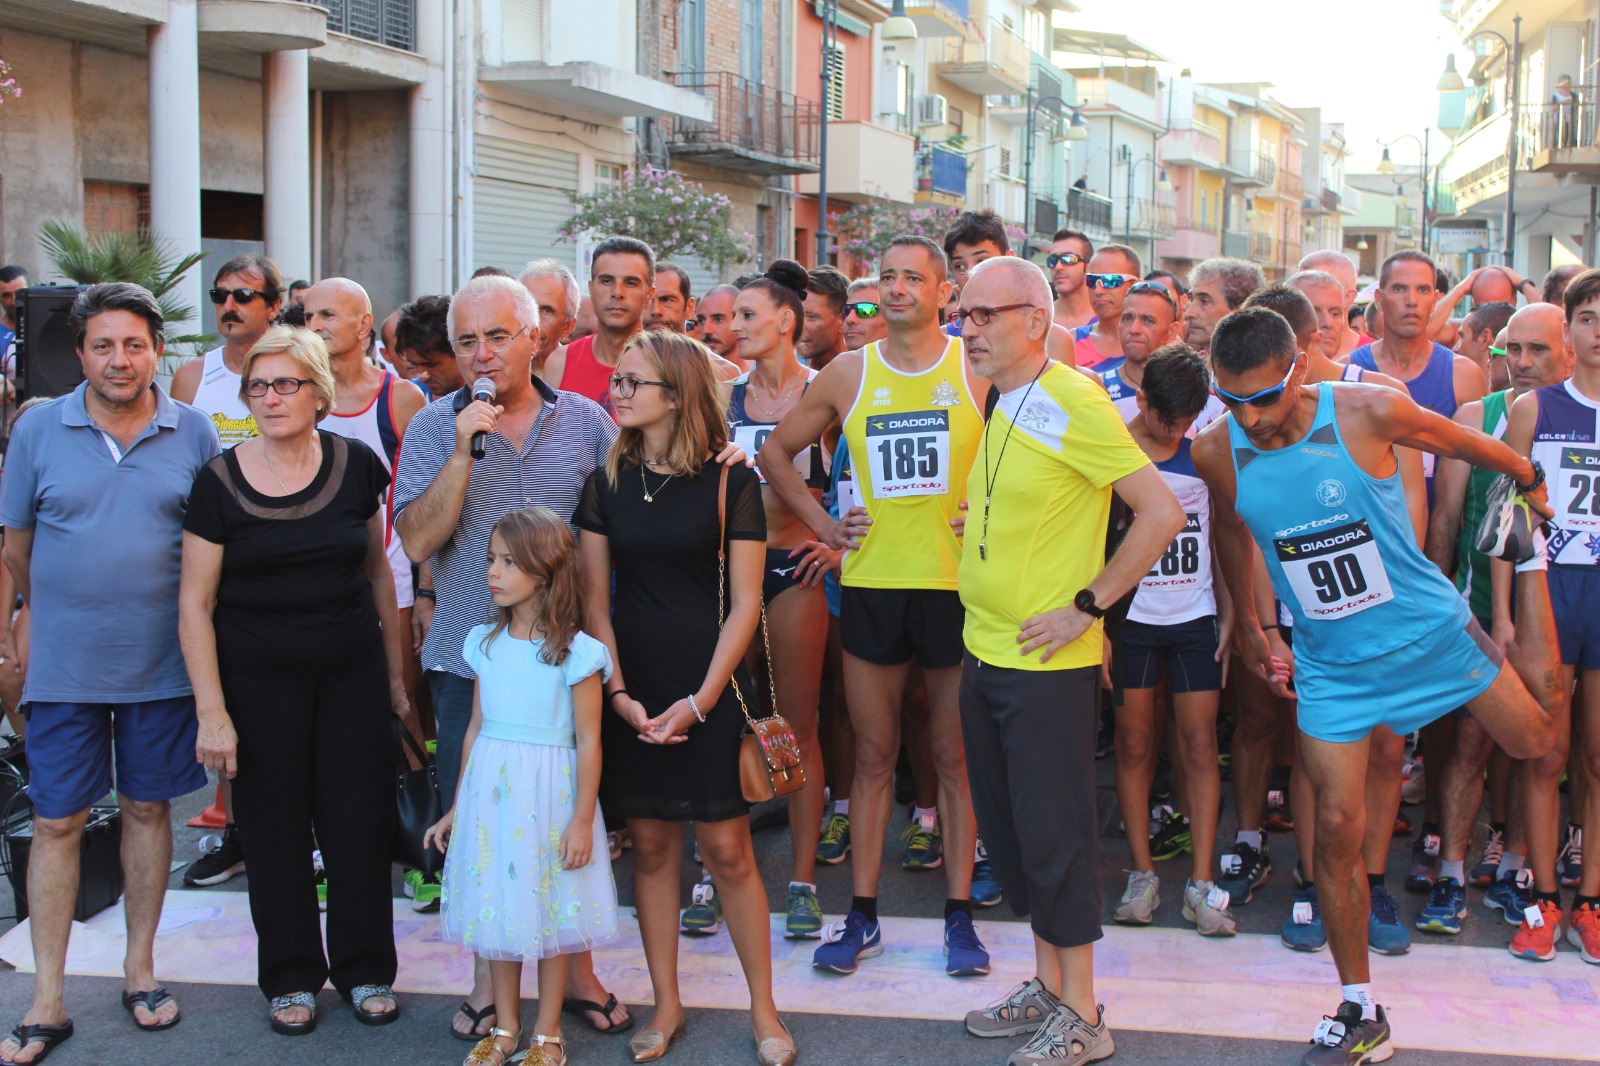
[574,330,795,1064]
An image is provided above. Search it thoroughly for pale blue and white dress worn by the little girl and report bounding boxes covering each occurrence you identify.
[440,626,616,959]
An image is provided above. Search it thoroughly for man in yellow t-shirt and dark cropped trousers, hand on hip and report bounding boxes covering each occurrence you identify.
[957,258,1184,1063]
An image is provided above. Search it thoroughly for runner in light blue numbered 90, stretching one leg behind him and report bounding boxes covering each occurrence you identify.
[1192,307,1555,1066]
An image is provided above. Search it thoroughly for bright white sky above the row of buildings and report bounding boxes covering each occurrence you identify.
[1064,0,1467,171]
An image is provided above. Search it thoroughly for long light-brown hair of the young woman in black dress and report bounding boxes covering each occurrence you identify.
[605,330,728,488]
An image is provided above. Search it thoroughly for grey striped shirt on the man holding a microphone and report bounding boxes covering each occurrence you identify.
[394,378,616,677]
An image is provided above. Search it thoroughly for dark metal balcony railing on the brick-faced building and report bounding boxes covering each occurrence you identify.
[667,70,821,174]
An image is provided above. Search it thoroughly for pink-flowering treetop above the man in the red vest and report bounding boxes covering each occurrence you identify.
[558,165,755,271]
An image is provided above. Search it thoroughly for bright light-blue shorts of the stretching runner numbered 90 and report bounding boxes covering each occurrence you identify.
[1294,614,1502,744]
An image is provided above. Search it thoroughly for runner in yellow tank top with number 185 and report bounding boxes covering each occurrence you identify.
[760,237,989,976]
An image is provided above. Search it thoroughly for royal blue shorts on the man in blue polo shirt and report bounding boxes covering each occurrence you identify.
[22,696,206,818]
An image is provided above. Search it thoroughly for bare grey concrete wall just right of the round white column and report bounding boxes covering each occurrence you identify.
[322,91,411,319]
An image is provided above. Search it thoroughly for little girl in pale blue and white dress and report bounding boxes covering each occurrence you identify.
[426,507,616,1066]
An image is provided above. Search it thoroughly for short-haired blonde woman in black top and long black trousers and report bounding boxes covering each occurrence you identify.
[179,327,406,1034]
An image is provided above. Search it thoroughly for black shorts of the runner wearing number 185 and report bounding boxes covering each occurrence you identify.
[838,584,966,671]
